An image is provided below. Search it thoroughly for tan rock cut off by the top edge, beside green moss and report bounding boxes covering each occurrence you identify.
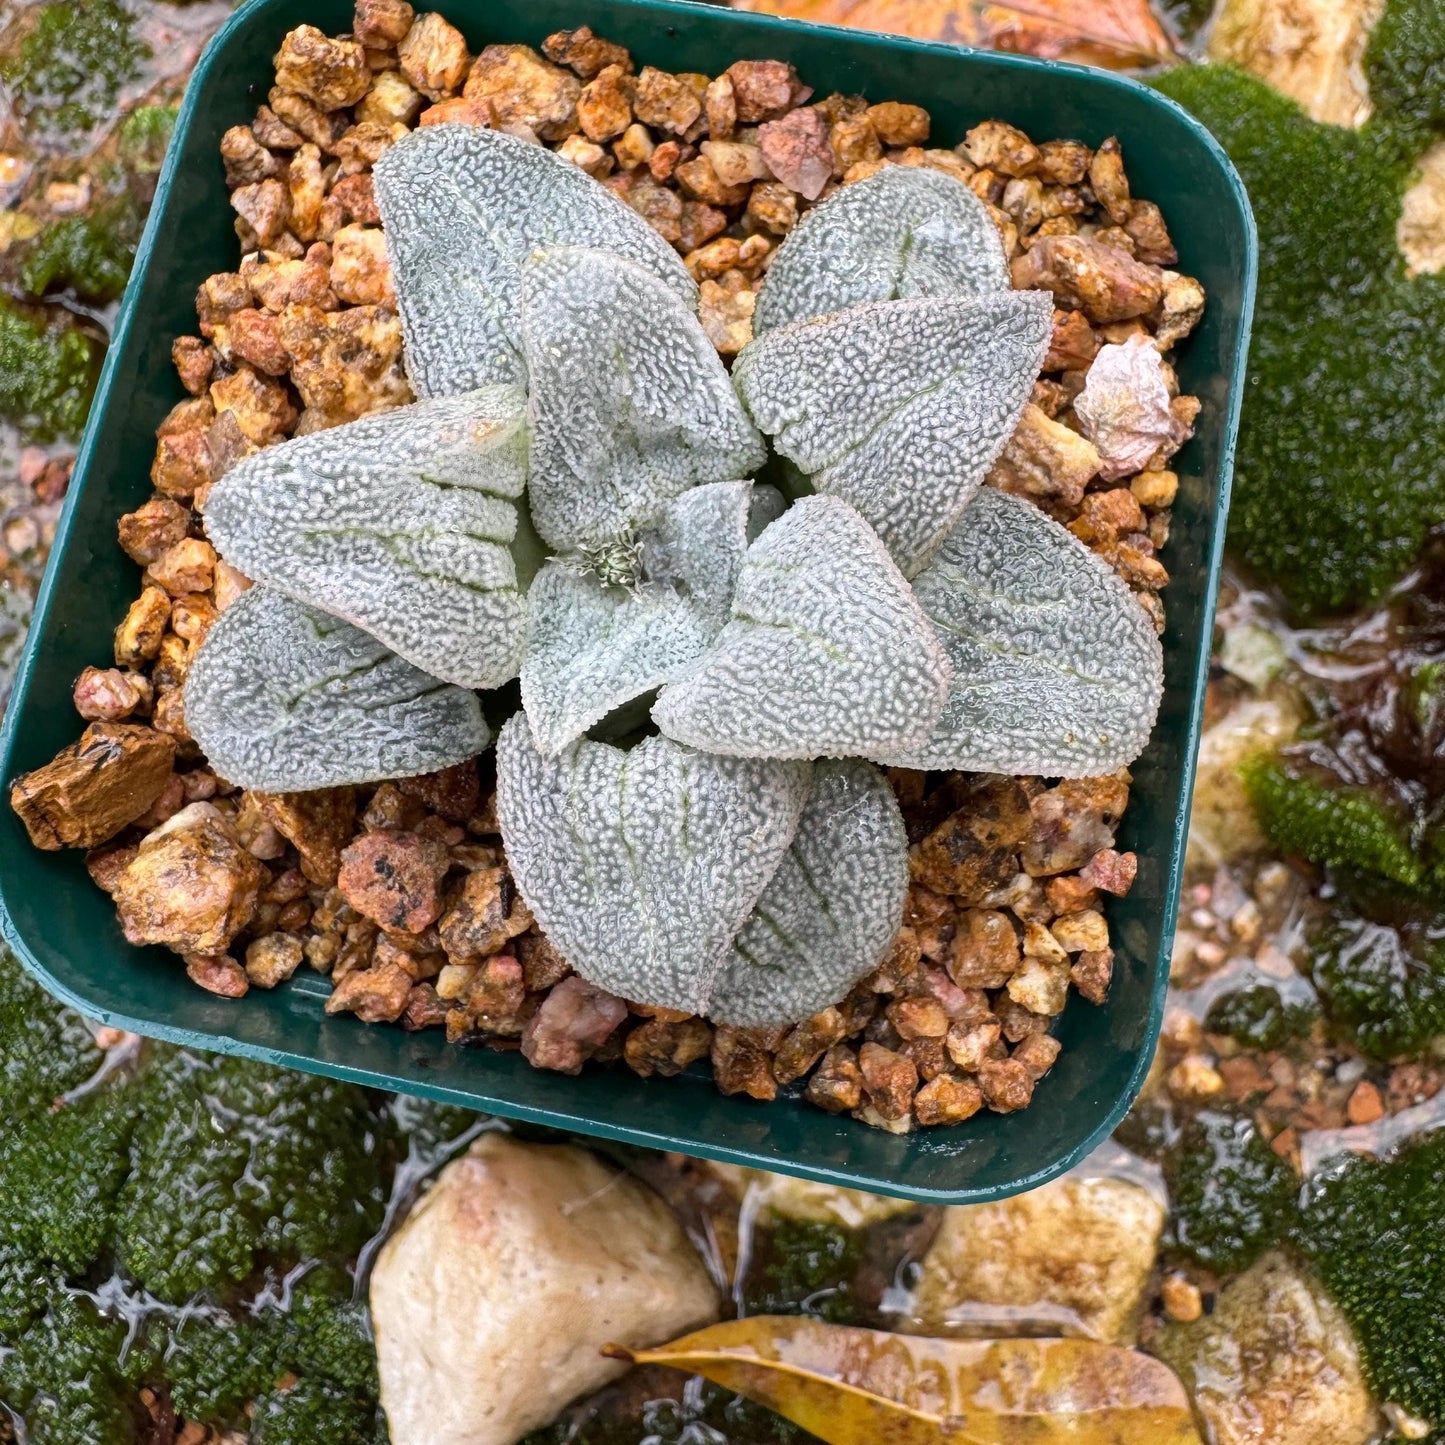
[1209,0,1384,126]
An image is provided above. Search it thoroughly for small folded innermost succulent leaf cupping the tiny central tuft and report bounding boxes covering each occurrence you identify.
[522,481,753,757]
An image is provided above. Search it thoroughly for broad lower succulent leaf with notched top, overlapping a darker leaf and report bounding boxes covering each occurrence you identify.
[497,714,812,1013]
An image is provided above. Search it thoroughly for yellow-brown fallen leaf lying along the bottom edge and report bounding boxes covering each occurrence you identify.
[605,1315,1199,1445]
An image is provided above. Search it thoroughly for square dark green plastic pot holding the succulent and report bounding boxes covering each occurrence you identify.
[0,0,1256,1204]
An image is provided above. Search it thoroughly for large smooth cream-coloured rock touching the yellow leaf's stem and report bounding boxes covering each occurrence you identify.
[371,1134,717,1445]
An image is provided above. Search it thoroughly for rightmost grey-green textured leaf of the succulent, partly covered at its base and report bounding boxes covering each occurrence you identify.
[871,487,1163,777]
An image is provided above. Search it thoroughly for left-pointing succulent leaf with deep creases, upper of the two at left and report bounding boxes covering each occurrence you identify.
[205,386,527,688]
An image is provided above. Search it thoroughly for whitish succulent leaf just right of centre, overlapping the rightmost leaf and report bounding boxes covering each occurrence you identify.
[652,497,948,757]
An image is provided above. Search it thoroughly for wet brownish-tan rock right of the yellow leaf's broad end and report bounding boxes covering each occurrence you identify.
[1157,1254,1380,1445]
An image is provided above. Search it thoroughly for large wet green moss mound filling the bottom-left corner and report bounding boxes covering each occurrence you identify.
[0,954,410,1445]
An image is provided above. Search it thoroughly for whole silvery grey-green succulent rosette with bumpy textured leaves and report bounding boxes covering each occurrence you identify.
[186,126,1162,1026]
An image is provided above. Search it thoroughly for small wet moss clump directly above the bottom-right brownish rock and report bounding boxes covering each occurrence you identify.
[1166,1110,1295,1272]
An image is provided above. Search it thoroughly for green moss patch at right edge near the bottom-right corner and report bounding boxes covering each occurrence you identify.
[1299,1133,1445,1439]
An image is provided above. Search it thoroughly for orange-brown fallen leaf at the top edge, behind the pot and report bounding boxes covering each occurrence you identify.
[733,0,1178,68]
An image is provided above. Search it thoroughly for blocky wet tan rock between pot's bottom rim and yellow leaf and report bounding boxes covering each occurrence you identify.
[909,1176,1165,1344]
